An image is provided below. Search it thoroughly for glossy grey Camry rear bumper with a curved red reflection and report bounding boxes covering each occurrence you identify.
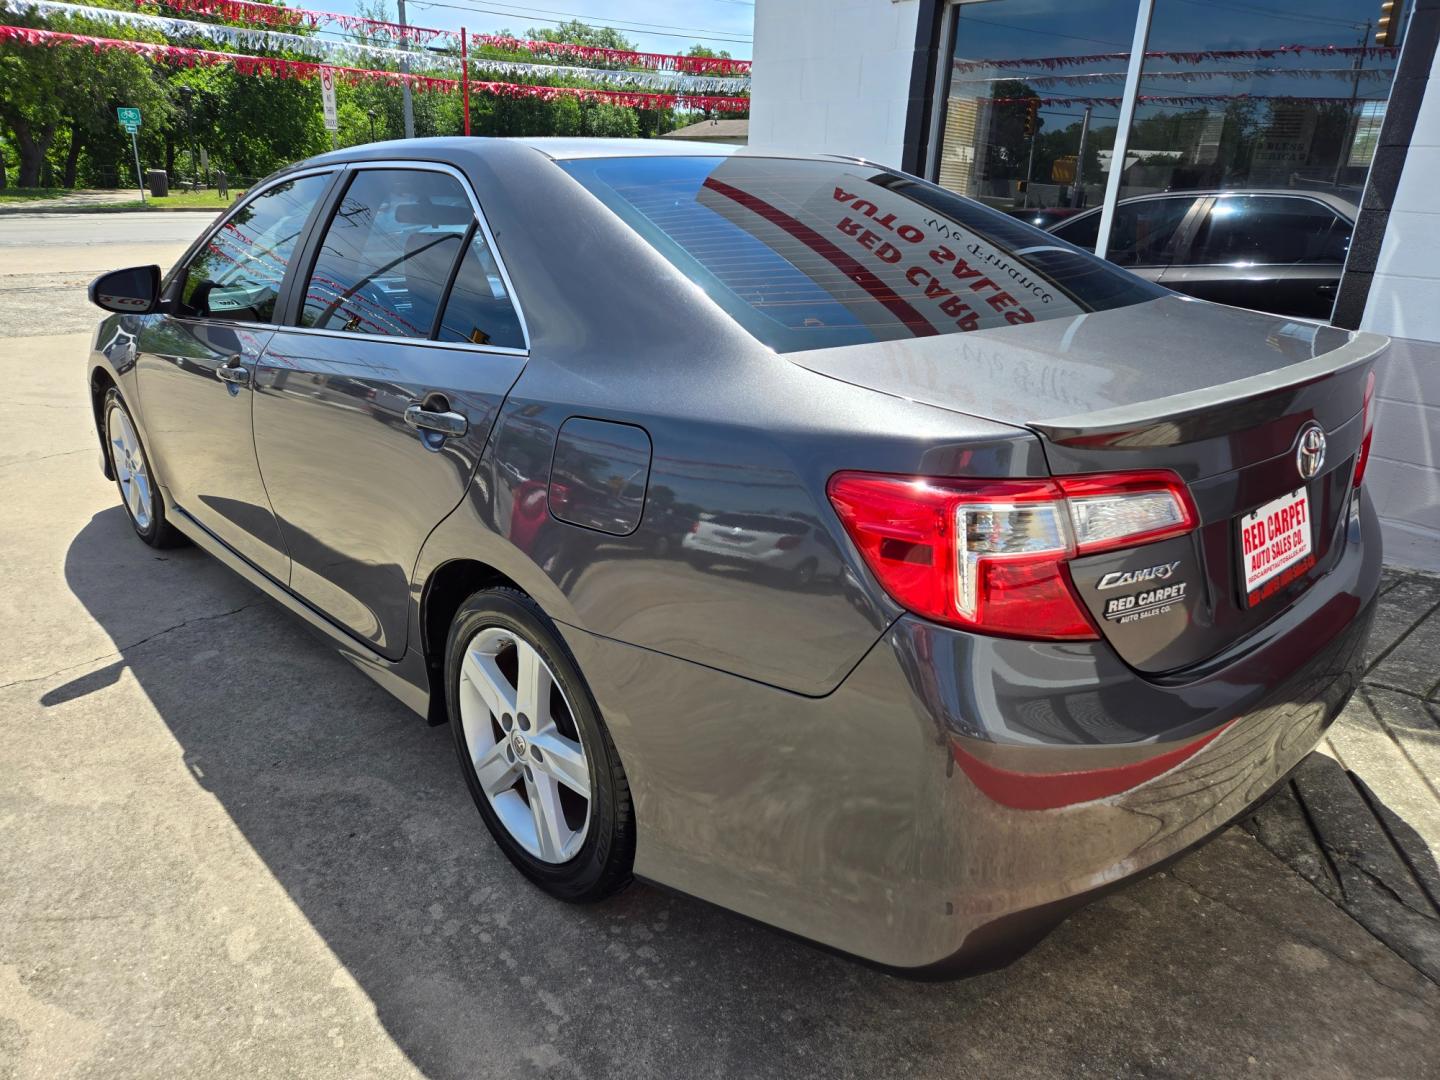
[555,489,1380,976]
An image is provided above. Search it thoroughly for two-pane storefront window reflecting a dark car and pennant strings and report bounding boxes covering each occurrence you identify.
[932,0,1408,279]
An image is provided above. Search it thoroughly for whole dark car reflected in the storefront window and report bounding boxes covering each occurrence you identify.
[1047,189,1358,320]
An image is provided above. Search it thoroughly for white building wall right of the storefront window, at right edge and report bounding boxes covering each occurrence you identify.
[1361,43,1440,570]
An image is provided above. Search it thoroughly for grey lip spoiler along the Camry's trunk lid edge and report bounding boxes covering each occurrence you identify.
[1025,331,1390,449]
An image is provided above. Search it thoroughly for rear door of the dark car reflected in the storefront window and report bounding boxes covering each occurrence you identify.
[1165,194,1351,318]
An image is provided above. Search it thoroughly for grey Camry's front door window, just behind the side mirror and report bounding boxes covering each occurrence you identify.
[180,174,330,323]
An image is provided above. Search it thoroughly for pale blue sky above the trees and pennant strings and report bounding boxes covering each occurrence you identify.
[349,0,755,59]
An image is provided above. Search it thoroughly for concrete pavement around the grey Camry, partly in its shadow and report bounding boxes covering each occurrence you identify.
[0,215,1440,1080]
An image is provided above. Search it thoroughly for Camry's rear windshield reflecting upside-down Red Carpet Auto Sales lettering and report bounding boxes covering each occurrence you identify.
[560,156,1165,353]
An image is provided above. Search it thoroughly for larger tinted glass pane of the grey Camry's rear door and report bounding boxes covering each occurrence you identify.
[301,168,475,337]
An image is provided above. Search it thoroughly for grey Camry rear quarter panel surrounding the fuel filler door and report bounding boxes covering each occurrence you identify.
[415,145,1044,696]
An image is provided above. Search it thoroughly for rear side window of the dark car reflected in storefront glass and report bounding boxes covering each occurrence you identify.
[1189,196,1351,264]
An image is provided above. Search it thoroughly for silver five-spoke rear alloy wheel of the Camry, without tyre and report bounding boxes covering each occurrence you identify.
[459,626,590,864]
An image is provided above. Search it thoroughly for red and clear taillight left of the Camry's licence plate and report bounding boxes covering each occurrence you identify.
[827,471,1198,641]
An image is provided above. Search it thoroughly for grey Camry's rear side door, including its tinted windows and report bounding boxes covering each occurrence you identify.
[253,163,527,658]
